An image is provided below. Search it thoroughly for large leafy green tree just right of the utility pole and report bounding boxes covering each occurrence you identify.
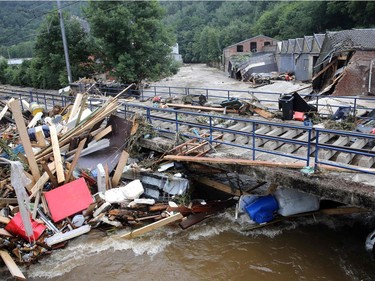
[86,1,174,83]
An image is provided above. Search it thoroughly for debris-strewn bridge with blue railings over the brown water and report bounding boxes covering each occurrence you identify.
[0,86,375,209]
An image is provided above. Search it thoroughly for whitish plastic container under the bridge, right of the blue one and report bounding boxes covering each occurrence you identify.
[274,188,319,216]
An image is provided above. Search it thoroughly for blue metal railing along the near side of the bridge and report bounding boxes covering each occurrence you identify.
[1,86,375,174]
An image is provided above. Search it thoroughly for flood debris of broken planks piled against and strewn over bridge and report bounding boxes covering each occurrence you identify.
[0,79,374,279]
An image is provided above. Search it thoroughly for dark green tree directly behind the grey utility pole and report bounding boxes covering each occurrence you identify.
[30,12,90,89]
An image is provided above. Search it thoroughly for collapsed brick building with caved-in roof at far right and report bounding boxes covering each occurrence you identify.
[313,29,375,96]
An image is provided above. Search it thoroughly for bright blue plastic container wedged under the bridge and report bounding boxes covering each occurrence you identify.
[245,195,278,223]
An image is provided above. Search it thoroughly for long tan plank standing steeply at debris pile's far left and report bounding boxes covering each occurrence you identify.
[9,100,40,181]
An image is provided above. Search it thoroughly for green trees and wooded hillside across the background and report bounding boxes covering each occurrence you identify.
[0,1,375,88]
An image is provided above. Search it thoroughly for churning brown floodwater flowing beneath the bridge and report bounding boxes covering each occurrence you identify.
[0,210,375,281]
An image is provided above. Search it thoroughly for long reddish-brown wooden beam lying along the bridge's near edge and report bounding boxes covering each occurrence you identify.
[163,155,366,172]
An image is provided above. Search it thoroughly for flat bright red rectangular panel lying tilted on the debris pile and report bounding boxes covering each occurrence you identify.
[44,178,93,222]
